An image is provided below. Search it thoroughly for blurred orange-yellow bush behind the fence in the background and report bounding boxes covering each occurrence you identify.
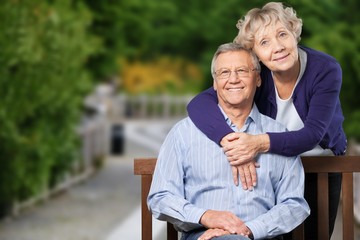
[121,56,203,95]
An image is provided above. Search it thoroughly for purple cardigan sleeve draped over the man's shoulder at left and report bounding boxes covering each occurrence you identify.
[187,87,233,145]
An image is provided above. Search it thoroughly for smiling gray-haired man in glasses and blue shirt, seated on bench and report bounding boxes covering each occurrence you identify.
[148,43,310,240]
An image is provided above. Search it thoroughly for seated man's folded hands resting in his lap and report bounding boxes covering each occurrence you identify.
[200,210,248,234]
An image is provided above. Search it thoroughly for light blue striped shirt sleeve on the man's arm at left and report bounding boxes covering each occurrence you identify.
[147,123,206,232]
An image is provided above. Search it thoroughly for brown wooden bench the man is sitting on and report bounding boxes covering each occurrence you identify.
[134,156,360,240]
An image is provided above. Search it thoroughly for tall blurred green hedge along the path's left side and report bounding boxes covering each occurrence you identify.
[0,0,96,213]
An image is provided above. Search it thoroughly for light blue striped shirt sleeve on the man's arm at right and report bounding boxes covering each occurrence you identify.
[246,157,310,239]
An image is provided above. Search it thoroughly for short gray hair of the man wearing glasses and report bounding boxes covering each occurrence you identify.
[211,42,261,79]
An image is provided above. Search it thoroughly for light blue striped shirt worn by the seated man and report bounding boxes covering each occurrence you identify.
[148,105,310,239]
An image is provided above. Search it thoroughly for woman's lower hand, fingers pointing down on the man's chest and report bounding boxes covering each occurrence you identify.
[231,161,260,190]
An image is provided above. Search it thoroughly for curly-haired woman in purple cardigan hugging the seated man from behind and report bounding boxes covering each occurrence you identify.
[188,2,347,240]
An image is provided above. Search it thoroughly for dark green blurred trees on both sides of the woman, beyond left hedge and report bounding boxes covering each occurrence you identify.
[85,0,360,140]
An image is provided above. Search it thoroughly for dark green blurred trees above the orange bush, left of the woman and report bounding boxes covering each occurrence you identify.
[85,0,256,77]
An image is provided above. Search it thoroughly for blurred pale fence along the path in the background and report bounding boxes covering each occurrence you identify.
[11,95,192,215]
